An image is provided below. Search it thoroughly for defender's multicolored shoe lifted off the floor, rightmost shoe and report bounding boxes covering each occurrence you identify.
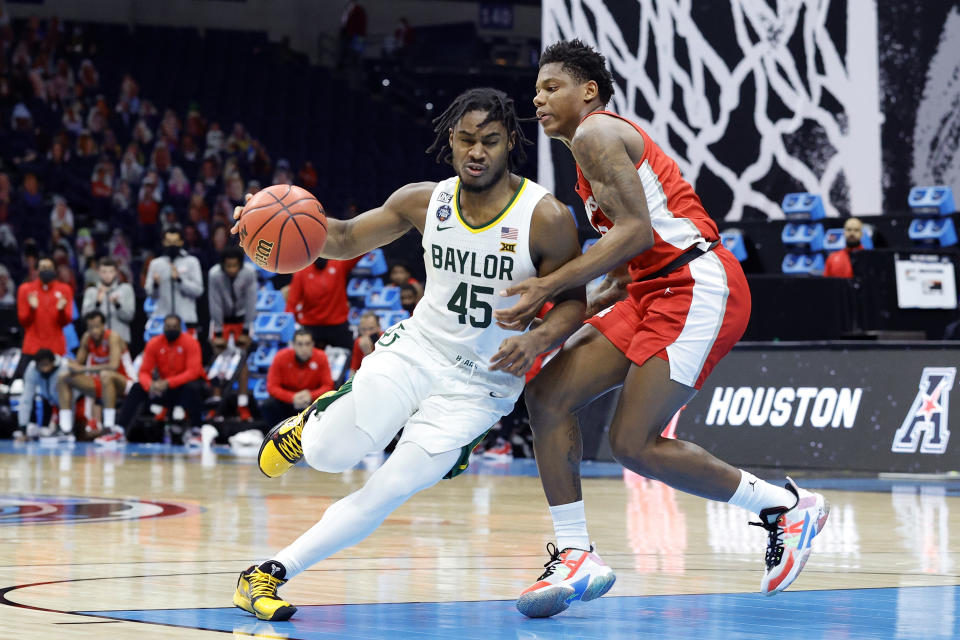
[750,477,830,596]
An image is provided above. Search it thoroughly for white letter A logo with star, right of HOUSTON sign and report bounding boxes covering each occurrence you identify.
[890,367,957,454]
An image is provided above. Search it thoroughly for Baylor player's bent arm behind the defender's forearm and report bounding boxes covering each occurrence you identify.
[490,195,586,376]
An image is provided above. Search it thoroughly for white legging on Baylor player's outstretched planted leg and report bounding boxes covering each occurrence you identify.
[273,442,460,580]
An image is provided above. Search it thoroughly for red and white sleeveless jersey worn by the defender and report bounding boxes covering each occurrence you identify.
[577,111,720,280]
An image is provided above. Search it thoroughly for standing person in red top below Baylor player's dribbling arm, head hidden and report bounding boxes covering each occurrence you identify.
[287,256,362,349]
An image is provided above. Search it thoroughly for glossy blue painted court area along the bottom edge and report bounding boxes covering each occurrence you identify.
[82,586,960,640]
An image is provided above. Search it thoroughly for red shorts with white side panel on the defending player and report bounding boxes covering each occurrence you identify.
[587,245,750,389]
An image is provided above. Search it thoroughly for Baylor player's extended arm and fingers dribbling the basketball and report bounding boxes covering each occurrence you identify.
[230,182,436,260]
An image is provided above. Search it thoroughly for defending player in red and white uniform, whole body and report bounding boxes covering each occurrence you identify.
[495,40,828,617]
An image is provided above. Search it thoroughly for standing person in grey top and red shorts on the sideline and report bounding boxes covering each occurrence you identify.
[207,245,257,420]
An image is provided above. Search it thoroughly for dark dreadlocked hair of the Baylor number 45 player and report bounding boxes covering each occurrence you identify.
[426,87,533,171]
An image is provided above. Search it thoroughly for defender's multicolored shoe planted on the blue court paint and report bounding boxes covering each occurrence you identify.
[517,542,617,618]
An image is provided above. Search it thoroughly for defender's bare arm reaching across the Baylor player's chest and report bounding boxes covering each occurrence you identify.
[494,117,653,325]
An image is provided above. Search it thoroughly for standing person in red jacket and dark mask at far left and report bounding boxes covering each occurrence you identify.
[17,256,73,358]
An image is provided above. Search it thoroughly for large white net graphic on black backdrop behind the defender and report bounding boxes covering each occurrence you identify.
[539,0,882,220]
